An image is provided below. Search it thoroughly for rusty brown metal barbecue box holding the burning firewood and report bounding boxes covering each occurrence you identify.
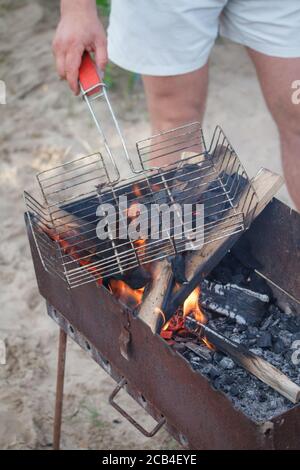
[26,199,300,449]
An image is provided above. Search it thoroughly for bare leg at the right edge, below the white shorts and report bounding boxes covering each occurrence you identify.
[248,48,300,211]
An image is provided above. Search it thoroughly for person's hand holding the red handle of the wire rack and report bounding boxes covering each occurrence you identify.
[53,0,108,95]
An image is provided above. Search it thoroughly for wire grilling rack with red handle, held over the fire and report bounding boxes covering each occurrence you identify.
[24,52,257,288]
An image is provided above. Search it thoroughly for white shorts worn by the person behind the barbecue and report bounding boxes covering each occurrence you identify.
[108,0,300,75]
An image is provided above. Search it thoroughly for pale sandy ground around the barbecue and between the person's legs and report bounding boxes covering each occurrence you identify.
[0,0,289,449]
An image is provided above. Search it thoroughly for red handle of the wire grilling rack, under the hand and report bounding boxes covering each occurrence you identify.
[79,52,102,96]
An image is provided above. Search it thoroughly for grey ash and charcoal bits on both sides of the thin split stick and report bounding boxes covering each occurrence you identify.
[180,305,300,422]
